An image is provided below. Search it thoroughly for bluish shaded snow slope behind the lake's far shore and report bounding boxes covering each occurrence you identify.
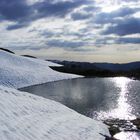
[0,50,79,88]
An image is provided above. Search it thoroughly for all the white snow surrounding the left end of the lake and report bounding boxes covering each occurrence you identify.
[0,51,109,140]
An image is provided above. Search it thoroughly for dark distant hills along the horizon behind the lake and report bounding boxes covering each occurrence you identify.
[47,60,140,78]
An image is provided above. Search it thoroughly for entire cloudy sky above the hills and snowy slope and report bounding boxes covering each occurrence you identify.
[0,0,140,63]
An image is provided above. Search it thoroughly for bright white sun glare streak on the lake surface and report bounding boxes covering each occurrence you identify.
[94,77,136,119]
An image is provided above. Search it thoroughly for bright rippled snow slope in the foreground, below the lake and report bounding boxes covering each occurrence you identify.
[0,86,109,140]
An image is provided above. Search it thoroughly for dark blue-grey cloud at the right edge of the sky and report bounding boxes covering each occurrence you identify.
[102,17,140,36]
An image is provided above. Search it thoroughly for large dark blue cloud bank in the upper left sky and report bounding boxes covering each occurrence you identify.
[0,0,88,30]
